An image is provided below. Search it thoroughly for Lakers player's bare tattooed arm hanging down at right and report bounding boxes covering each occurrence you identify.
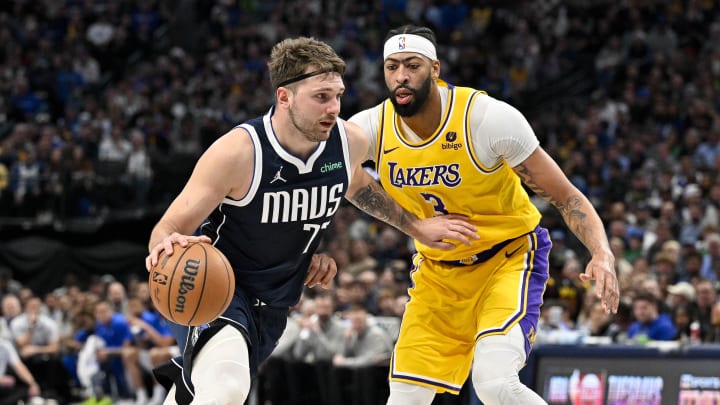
[514,147,620,312]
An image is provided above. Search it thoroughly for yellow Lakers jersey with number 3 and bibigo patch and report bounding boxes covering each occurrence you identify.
[375,86,540,260]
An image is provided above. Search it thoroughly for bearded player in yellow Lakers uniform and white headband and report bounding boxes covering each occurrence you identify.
[350,26,619,405]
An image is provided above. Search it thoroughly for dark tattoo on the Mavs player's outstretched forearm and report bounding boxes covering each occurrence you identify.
[349,183,414,233]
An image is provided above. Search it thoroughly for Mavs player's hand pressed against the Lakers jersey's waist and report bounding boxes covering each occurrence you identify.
[412,214,480,250]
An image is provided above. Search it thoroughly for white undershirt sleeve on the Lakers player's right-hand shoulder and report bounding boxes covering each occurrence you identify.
[470,95,540,167]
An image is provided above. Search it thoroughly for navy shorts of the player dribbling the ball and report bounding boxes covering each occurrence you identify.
[153,289,289,405]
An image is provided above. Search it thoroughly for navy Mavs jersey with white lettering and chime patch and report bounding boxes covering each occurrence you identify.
[202,109,350,307]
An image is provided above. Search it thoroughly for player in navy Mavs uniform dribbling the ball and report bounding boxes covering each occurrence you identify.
[146,38,477,404]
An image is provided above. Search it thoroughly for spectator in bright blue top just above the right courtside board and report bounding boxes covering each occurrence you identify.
[627,293,676,343]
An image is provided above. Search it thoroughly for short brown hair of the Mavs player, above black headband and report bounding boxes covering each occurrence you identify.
[268,37,345,88]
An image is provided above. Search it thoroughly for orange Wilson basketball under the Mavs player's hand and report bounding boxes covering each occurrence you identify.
[149,242,235,326]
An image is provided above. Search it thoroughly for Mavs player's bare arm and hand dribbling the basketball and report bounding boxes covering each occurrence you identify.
[145,128,255,271]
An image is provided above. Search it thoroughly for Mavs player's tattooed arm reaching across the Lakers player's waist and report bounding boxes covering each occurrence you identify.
[345,122,479,250]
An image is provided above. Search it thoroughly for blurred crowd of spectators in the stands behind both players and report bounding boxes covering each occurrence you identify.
[0,0,720,403]
